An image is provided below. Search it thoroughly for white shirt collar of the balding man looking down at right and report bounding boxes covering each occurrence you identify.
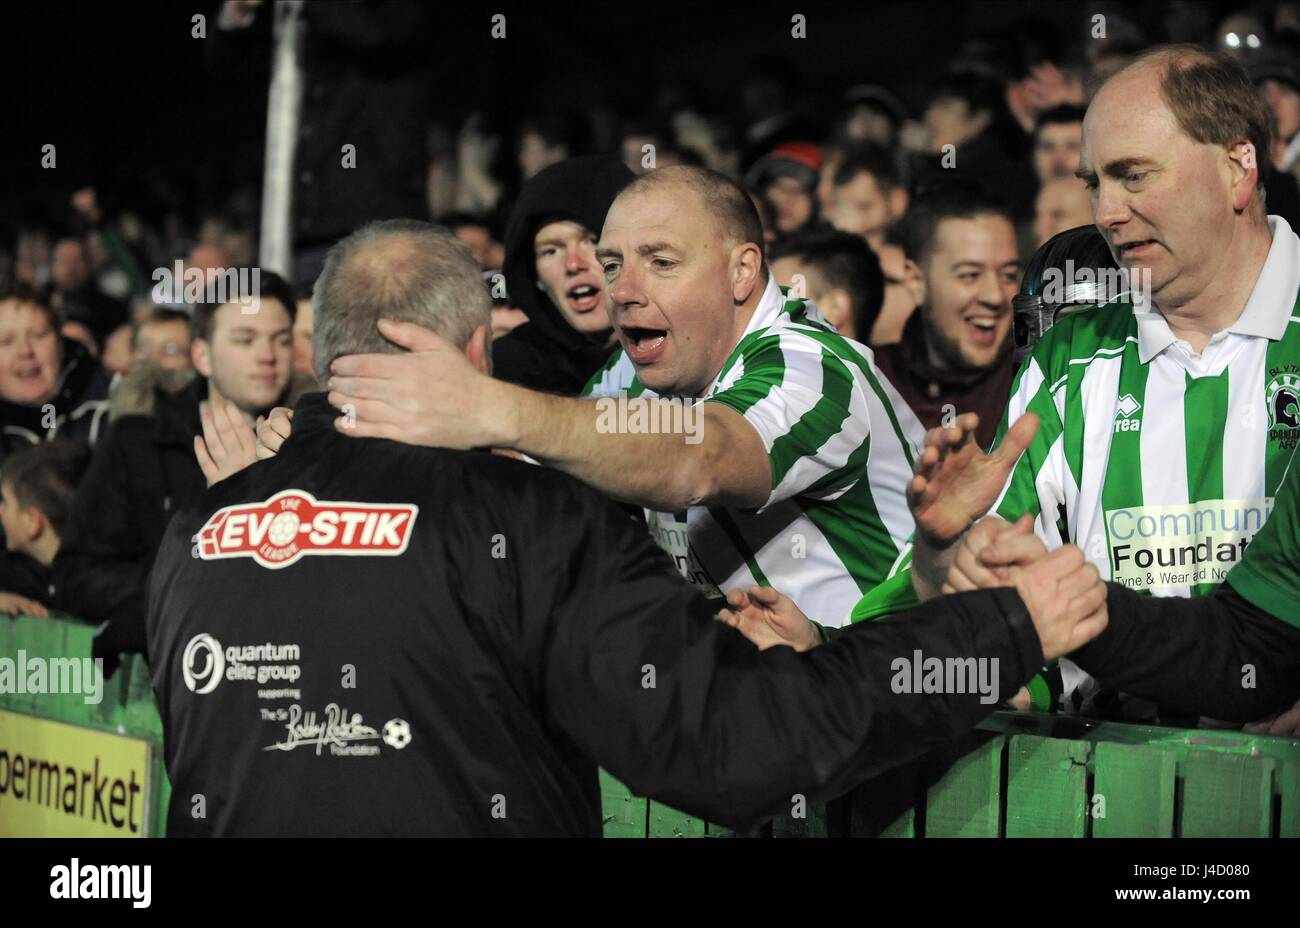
[1134,216,1300,364]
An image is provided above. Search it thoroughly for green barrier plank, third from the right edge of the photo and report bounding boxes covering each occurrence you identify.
[1088,742,1178,838]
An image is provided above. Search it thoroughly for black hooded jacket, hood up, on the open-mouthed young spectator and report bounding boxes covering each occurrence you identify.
[493,156,632,394]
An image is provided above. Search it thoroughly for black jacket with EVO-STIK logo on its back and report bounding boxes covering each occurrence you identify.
[148,394,1043,836]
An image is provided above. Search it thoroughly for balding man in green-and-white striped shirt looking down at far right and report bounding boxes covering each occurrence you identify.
[894,48,1300,712]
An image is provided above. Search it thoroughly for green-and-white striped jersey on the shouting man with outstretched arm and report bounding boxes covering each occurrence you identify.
[582,271,924,625]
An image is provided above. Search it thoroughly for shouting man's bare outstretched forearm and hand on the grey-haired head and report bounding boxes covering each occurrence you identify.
[329,320,771,511]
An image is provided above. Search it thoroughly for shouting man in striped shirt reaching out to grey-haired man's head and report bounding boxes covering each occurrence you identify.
[330,168,923,625]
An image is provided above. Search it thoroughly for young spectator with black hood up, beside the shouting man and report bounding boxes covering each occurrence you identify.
[493,156,633,394]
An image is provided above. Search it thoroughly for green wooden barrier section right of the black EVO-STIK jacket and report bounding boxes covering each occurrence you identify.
[595,712,1300,837]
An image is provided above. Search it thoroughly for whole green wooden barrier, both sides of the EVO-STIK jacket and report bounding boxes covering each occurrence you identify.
[0,616,1300,838]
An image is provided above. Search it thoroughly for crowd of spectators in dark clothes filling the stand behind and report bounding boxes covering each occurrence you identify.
[0,3,1300,696]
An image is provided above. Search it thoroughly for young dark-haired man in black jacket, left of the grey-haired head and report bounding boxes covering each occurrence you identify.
[53,272,296,662]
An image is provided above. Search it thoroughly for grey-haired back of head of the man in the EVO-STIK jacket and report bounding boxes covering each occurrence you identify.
[312,220,491,382]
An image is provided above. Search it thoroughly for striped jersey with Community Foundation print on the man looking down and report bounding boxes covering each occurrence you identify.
[995,217,1300,595]
